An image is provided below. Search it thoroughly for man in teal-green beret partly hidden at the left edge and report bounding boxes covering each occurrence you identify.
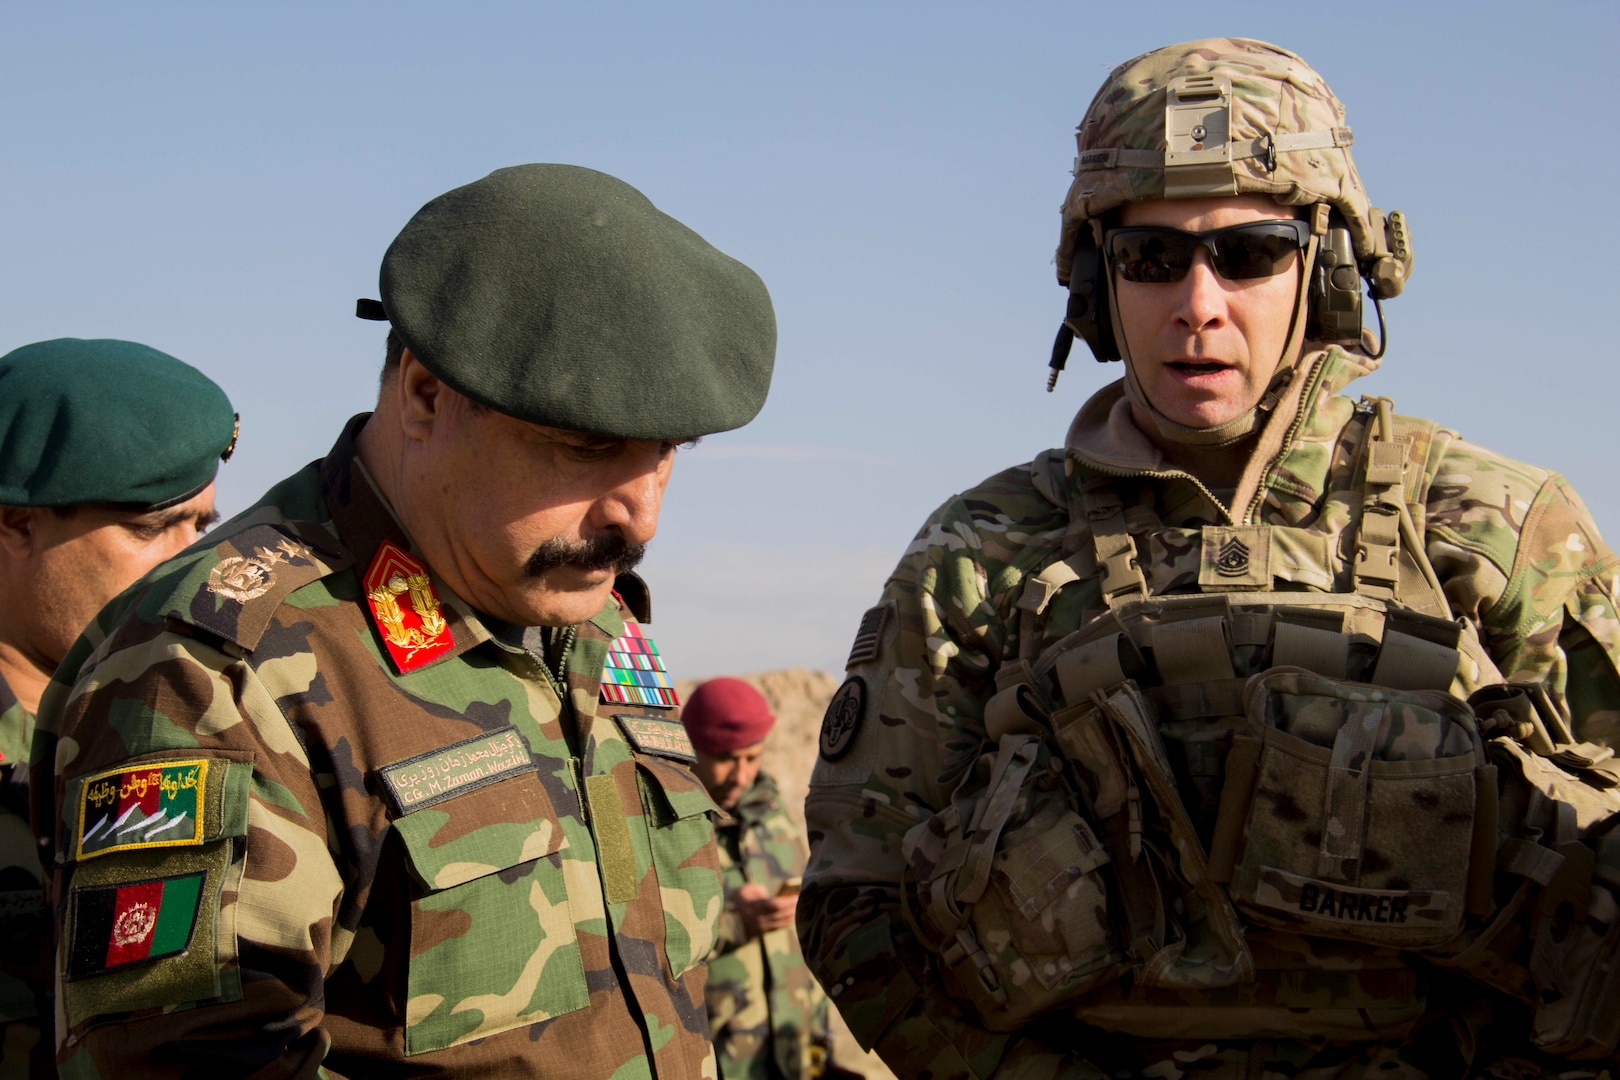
[0,338,237,1080]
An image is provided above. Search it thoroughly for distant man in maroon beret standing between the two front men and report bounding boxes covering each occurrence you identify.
[680,678,828,1080]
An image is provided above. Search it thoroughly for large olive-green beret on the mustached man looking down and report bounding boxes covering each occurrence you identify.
[370,165,776,439]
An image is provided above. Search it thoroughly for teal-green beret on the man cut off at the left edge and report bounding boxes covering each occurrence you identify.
[0,337,237,508]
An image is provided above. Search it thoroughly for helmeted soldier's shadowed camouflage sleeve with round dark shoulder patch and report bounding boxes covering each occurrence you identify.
[799,499,1103,1080]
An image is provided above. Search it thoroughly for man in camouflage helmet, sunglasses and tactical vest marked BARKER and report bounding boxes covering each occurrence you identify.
[799,39,1620,1078]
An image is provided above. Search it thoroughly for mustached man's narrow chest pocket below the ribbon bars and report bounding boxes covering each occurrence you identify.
[635,755,724,976]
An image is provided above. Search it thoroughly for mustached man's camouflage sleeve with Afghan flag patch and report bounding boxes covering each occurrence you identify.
[48,620,347,1078]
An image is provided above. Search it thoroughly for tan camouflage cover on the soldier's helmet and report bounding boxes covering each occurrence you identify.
[1058,37,1411,296]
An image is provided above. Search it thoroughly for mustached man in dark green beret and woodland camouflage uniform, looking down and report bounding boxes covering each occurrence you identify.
[36,165,776,1078]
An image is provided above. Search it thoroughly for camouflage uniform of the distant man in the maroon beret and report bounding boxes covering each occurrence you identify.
[705,772,826,1080]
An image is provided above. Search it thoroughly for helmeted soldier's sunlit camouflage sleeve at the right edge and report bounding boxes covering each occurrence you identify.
[1426,442,1620,746]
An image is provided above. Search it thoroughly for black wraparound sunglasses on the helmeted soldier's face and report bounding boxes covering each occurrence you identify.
[1106,219,1311,285]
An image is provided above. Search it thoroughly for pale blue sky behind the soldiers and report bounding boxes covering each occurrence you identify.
[0,0,1620,675]
